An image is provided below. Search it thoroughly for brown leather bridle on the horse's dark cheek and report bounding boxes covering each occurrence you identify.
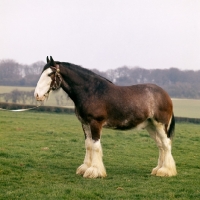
[46,65,62,95]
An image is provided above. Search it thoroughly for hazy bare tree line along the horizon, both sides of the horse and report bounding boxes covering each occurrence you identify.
[0,60,200,99]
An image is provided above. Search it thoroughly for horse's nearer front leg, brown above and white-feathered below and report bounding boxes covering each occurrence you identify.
[78,121,106,178]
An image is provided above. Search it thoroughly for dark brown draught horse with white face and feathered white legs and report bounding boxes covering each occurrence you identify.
[34,56,177,178]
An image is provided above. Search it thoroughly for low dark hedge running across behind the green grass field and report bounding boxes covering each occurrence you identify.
[0,102,200,124]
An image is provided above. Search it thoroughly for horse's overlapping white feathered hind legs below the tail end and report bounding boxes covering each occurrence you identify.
[147,122,177,176]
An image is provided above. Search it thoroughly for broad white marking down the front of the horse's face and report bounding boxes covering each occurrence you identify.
[34,68,52,101]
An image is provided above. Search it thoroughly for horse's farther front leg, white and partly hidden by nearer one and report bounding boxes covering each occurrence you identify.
[76,124,93,175]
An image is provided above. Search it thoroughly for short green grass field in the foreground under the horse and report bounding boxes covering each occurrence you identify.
[0,111,200,200]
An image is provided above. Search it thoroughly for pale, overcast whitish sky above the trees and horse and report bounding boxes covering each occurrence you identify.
[0,0,200,71]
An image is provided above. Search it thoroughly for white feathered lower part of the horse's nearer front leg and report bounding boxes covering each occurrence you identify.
[83,140,106,178]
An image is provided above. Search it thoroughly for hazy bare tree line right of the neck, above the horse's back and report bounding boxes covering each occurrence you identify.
[93,66,200,99]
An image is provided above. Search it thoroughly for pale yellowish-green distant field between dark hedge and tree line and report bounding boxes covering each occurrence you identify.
[0,86,200,118]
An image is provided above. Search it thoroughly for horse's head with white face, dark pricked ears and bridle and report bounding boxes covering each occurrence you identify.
[34,56,62,101]
